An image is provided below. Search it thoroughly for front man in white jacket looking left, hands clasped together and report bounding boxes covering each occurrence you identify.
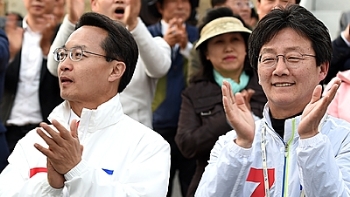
[0,12,170,197]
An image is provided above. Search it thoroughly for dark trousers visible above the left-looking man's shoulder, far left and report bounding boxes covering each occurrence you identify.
[6,124,39,153]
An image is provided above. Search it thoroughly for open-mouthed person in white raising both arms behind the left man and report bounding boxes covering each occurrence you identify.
[47,0,171,128]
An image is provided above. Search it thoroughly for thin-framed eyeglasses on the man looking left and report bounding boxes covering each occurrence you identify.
[53,46,116,62]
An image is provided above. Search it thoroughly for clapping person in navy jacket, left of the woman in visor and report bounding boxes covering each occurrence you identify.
[148,0,198,197]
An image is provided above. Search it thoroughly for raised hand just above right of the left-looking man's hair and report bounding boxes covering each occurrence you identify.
[122,0,141,31]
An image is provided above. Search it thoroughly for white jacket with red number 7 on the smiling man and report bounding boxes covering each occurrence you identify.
[195,107,350,197]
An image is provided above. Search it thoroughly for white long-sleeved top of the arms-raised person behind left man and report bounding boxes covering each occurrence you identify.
[47,15,171,128]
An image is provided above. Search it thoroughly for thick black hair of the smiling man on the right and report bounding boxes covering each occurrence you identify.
[248,4,332,69]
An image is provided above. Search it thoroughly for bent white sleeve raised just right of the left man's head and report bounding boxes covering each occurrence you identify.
[131,18,171,78]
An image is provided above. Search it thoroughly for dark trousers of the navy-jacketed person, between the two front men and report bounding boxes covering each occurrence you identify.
[154,128,196,197]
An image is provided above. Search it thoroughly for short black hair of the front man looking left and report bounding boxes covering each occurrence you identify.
[75,12,139,92]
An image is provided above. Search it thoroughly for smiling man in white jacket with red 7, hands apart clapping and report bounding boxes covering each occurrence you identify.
[195,5,350,197]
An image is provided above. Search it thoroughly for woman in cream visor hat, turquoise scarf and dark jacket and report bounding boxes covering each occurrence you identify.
[175,7,267,197]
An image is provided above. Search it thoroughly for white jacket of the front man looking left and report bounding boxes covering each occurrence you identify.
[0,94,170,197]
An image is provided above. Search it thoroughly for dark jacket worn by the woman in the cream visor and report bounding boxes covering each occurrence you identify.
[175,72,267,197]
